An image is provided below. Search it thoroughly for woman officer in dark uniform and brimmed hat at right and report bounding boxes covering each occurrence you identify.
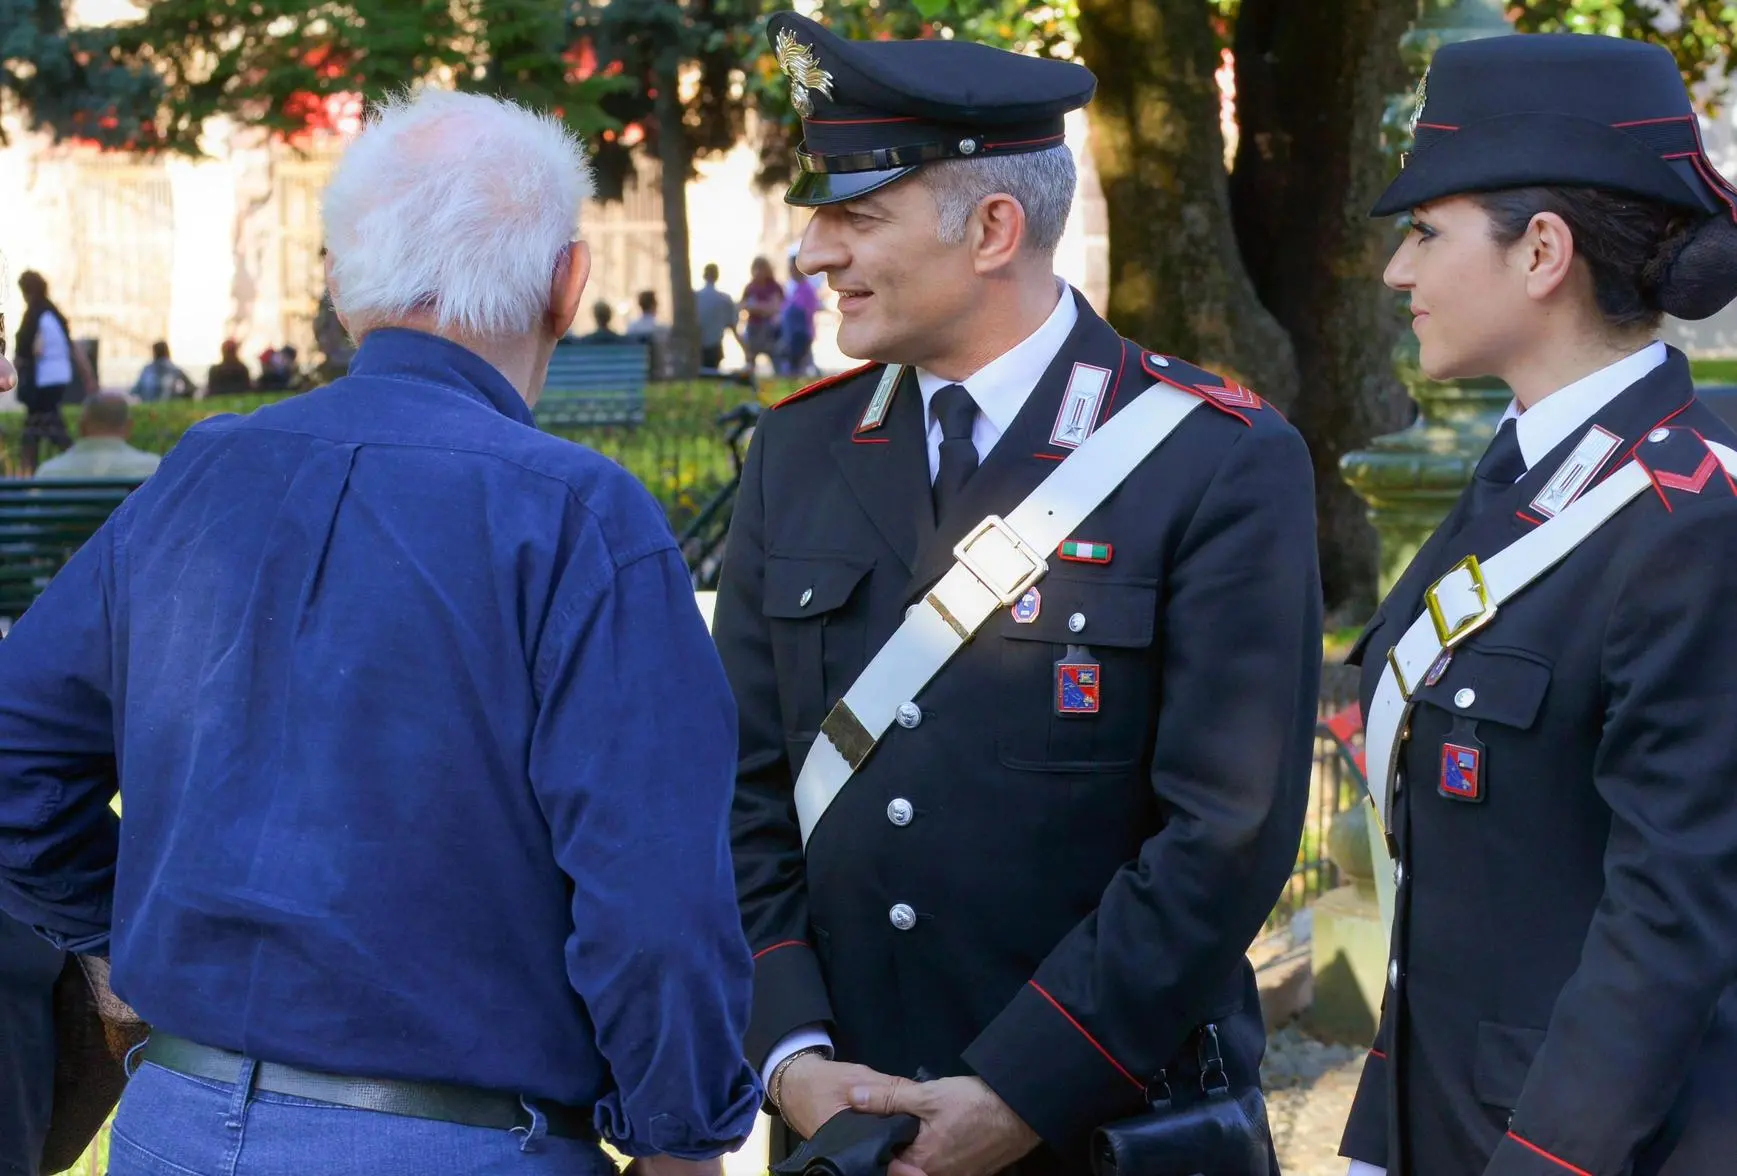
[1343,36,1737,1176]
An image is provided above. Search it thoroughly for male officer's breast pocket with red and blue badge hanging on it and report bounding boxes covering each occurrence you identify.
[994,573,1159,773]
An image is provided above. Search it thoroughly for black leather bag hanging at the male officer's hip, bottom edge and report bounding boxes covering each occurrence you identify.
[1091,1025,1273,1176]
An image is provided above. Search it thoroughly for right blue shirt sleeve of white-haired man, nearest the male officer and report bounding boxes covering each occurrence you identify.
[530,547,761,1159]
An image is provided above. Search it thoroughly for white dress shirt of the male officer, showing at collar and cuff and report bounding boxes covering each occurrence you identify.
[761,281,1080,1087]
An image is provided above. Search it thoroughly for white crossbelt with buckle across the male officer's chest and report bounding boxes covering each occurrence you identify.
[796,384,1202,848]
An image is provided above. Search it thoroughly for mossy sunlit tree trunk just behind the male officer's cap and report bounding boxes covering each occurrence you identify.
[1079,0,1313,408]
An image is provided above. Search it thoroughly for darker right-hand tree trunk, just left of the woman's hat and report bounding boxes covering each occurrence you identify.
[1230,0,1417,624]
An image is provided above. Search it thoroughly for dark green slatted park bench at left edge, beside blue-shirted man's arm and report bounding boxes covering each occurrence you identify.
[0,478,139,636]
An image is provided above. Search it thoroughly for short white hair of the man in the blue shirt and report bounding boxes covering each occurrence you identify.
[323,89,591,339]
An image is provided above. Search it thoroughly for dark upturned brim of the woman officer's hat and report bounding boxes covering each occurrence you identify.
[1369,113,1706,217]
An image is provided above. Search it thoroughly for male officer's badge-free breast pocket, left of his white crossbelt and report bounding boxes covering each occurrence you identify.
[761,556,872,738]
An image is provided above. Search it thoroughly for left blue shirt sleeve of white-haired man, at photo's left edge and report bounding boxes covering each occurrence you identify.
[0,518,120,954]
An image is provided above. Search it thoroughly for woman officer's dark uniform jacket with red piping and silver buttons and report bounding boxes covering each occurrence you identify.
[1343,344,1737,1176]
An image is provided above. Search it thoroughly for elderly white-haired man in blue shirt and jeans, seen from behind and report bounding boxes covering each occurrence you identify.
[0,92,761,1176]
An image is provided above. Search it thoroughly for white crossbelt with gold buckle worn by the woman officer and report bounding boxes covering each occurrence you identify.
[1364,441,1737,851]
